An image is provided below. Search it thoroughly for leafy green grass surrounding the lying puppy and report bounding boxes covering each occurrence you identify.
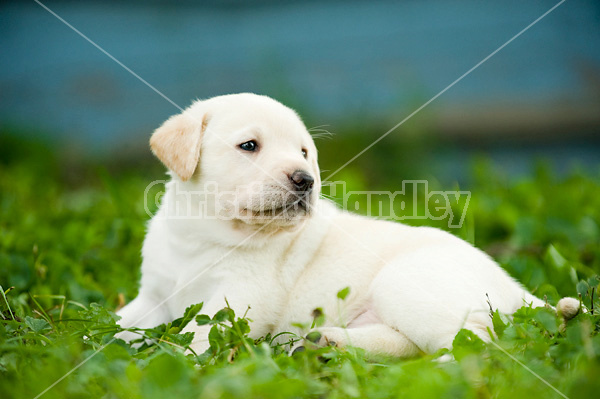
[0,138,600,399]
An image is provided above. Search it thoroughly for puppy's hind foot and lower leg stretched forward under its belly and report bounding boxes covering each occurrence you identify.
[294,324,421,357]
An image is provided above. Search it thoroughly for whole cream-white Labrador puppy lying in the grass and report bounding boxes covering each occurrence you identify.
[118,94,579,357]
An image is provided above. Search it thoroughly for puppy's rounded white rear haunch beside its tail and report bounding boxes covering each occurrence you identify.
[370,248,502,353]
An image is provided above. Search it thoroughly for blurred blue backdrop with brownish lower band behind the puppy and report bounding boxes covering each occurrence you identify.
[0,0,600,181]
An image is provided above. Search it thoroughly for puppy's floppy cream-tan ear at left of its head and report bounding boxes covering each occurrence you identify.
[150,113,208,181]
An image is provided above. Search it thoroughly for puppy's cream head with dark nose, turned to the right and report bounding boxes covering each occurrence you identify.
[150,94,321,228]
